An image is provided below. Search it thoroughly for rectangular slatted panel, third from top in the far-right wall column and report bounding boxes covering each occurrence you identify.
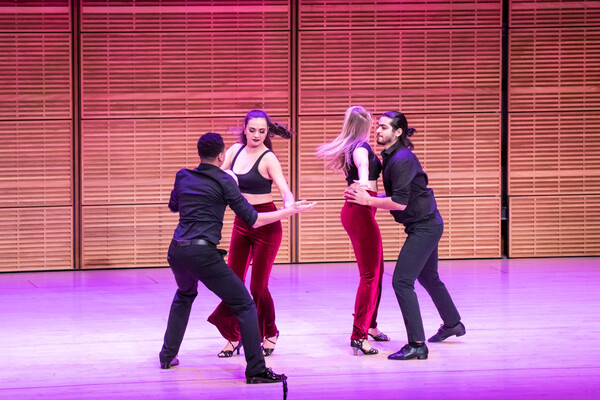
[508,112,600,195]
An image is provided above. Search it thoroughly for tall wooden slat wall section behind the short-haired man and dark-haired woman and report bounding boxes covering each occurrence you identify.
[81,0,291,268]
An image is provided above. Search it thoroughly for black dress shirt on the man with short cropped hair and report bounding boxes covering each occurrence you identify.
[169,163,258,245]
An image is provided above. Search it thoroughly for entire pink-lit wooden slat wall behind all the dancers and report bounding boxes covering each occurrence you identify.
[0,0,600,271]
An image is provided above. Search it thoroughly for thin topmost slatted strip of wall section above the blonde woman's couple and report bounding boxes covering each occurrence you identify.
[299,0,502,30]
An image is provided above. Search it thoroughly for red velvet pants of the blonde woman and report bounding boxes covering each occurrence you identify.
[341,191,383,339]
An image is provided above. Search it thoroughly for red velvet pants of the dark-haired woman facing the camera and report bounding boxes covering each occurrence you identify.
[208,202,283,342]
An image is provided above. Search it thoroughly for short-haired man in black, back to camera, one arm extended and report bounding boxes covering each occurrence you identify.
[160,132,315,383]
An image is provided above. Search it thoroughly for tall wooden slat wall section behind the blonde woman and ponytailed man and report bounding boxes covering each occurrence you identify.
[298,0,501,262]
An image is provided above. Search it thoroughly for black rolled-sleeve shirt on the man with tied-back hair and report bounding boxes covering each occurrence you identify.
[381,141,437,225]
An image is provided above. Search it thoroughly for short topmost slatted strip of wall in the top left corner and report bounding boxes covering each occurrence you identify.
[0,0,71,32]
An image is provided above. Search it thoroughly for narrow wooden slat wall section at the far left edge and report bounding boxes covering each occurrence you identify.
[0,0,73,271]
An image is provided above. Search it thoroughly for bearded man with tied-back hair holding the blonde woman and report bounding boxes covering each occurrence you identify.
[345,111,466,360]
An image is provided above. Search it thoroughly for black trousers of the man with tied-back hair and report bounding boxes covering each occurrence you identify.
[392,212,460,342]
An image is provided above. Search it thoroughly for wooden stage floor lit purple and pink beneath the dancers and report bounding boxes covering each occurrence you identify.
[0,258,600,400]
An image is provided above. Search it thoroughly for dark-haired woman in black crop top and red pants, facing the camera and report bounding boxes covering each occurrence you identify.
[208,110,294,358]
